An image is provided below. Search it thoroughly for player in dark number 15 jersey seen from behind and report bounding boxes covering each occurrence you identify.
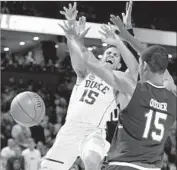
[99,14,176,170]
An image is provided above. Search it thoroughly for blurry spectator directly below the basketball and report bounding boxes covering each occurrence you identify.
[11,124,31,149]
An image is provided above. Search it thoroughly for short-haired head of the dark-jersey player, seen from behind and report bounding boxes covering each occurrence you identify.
[141,45,168,73]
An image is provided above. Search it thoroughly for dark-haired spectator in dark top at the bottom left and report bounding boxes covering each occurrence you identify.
[6,145,25,170]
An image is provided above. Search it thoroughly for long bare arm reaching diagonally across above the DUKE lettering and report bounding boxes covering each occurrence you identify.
[58,16,137,97]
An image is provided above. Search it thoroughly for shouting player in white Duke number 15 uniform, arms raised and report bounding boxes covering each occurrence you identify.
[41,3,136,170]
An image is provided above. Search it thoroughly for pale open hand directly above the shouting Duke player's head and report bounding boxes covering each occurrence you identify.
[98,23,120,45]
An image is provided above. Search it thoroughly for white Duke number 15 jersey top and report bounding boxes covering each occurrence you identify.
[66,73,117,128]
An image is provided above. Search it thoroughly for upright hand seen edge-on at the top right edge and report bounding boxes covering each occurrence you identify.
[122,0,133,29]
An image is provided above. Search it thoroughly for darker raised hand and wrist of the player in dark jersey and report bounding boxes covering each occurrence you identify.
[110,15,131,41]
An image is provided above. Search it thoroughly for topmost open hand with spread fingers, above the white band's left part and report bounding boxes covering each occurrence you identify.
[60,2,78,21]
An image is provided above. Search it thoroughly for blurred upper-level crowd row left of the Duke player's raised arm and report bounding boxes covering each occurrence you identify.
[1,48,71,73]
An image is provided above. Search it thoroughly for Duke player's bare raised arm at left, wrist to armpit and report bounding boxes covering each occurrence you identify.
[67,40,89,78]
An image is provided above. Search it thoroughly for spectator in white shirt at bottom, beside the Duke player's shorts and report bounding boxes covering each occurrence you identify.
[22,138,41,170]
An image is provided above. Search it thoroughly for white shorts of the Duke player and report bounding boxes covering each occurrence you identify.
[41,125,109,170]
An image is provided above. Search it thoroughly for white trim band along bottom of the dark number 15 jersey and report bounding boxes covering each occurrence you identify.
[109,162,161,170]
